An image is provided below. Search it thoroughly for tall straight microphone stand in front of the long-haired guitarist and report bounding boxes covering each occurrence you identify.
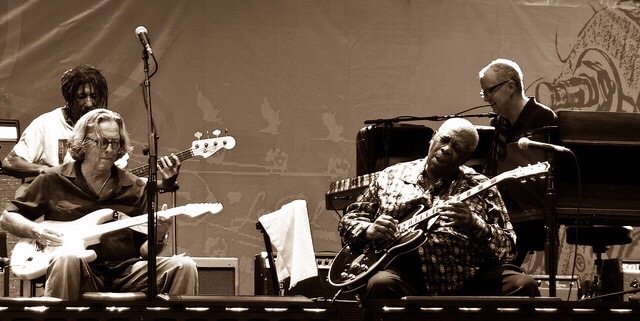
[142,49,158,301]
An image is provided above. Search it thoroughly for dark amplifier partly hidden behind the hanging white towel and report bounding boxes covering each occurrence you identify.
[254,252,350,298]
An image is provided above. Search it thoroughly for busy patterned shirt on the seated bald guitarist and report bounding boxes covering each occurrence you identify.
[339,158,516,295]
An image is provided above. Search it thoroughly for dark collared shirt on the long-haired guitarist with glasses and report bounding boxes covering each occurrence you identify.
[6,162,146,267]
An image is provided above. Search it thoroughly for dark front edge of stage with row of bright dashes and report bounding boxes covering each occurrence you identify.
[0,296,640,321]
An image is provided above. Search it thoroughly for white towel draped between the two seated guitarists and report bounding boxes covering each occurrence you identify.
[258,200,318,289]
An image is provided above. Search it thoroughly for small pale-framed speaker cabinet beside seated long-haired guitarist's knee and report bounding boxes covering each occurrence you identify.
[192,257,238,295]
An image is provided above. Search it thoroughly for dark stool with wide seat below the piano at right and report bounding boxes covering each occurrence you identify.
[567,225,633,299]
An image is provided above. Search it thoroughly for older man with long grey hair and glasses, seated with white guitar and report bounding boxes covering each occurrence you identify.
[0,109,197,300]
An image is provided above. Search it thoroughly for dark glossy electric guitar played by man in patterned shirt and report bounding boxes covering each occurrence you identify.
[328,162,550,293]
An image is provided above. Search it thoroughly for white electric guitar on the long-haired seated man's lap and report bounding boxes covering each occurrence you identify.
[10,203,222,280]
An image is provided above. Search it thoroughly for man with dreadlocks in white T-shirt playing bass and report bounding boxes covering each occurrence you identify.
[2,65,109,178]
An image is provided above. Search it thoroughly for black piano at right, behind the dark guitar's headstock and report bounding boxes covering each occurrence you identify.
[500,111,640,226]
